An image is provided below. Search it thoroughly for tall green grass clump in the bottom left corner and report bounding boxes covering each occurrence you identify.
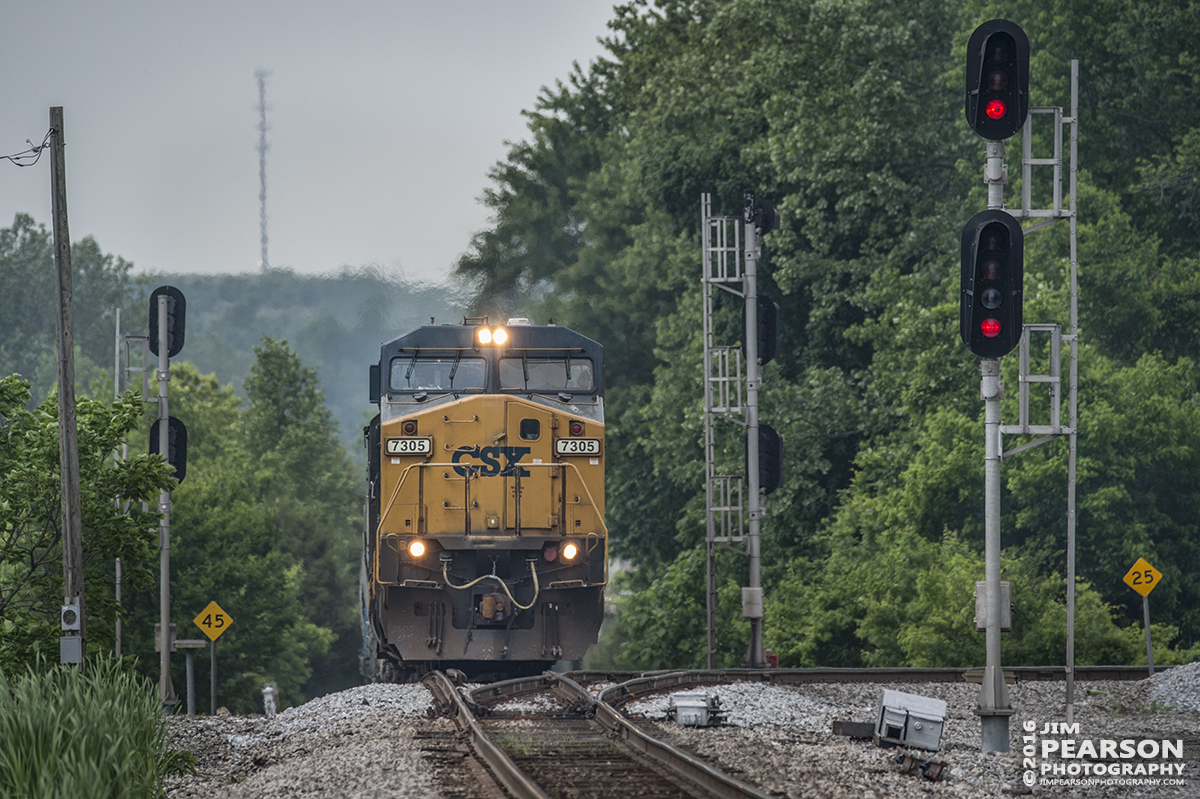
[0,657,187,799]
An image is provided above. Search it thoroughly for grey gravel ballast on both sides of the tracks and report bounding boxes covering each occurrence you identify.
[167,663,1200,799]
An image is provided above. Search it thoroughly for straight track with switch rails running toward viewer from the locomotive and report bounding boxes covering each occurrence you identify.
[426,672,769,799]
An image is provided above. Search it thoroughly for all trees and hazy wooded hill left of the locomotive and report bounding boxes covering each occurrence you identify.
[0,215,454,710]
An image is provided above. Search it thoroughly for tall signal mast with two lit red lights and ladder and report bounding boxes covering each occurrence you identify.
[959,19,1079,752]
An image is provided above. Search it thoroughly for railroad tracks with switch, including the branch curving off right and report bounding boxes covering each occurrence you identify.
[425,666,1171,799]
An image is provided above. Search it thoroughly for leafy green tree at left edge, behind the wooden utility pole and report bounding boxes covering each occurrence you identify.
[0,376,174,673]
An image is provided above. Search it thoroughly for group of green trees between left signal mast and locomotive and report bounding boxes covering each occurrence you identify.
[130,337,361,711]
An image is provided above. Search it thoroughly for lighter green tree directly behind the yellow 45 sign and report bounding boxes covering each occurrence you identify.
[126,361,334,713]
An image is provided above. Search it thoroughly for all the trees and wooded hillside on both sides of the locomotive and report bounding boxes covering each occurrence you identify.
[0,0,1200,695]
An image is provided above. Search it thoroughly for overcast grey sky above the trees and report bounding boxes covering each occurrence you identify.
[0,0,613,286]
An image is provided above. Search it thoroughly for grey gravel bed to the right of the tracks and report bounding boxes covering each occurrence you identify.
[624,663,1200,799]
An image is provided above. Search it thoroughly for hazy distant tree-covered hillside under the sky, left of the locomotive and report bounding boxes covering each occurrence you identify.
[0,220,461,457]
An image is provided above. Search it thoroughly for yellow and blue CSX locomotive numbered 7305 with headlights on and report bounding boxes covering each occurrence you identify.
[362,317,608,680]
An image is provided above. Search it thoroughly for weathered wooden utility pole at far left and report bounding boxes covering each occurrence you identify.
[50,107,86,671]
